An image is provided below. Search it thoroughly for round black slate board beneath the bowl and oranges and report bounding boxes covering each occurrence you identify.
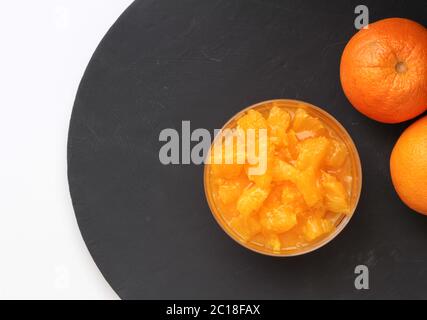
[68,0,427,299]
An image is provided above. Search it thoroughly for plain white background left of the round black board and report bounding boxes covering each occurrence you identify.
[0,0,132,299]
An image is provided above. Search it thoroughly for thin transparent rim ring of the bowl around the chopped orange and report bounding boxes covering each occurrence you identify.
[203,98,363,258]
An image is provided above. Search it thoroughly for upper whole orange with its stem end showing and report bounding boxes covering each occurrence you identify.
[340,18,427,123]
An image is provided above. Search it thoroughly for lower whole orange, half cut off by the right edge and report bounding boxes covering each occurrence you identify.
[390,116,427,215]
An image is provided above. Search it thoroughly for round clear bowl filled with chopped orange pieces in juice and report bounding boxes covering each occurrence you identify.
[204,99,362,257]
